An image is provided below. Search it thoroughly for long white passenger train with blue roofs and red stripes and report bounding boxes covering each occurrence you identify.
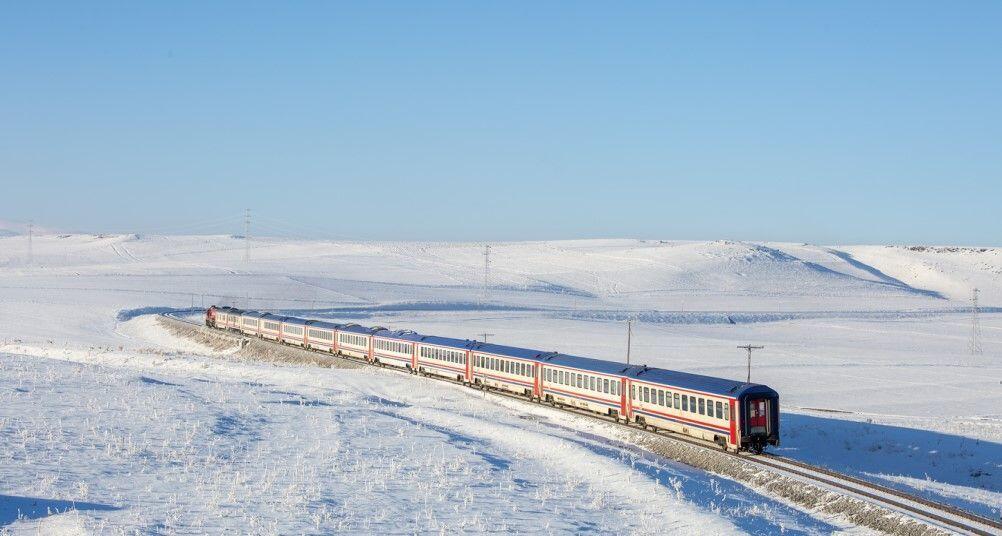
[205,306,780,453]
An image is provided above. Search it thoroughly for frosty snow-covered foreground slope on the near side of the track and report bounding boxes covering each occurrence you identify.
[0,318,853,534]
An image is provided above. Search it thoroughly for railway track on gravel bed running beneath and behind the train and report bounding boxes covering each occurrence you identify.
[161,313,1002,536]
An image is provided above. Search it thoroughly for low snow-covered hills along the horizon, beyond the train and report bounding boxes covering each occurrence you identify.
[0,234,1002,311]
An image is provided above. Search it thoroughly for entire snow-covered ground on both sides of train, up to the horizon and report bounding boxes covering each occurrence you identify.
[0,235,1002,533]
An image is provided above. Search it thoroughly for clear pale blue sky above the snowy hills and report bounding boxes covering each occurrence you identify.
[0,2,1002,245]
